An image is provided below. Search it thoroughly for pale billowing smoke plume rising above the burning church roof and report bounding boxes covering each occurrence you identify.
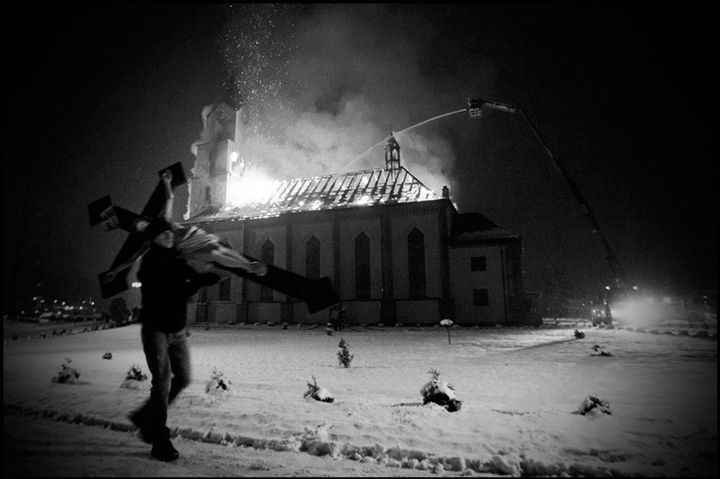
[197,4,496,192]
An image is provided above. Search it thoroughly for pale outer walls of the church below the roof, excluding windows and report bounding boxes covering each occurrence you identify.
[188,204,521,326]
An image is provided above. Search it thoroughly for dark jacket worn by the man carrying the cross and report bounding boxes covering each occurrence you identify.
[137,245,220,333]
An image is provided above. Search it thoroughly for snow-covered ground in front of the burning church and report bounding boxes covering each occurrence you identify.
[3,325,717,477]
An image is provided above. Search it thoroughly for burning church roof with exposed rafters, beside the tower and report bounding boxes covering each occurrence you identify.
[190,166,439,222]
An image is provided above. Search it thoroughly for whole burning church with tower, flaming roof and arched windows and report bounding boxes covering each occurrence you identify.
[184,103,528,325]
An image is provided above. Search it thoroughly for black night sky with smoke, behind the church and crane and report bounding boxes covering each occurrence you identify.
[3,2,720,316]
